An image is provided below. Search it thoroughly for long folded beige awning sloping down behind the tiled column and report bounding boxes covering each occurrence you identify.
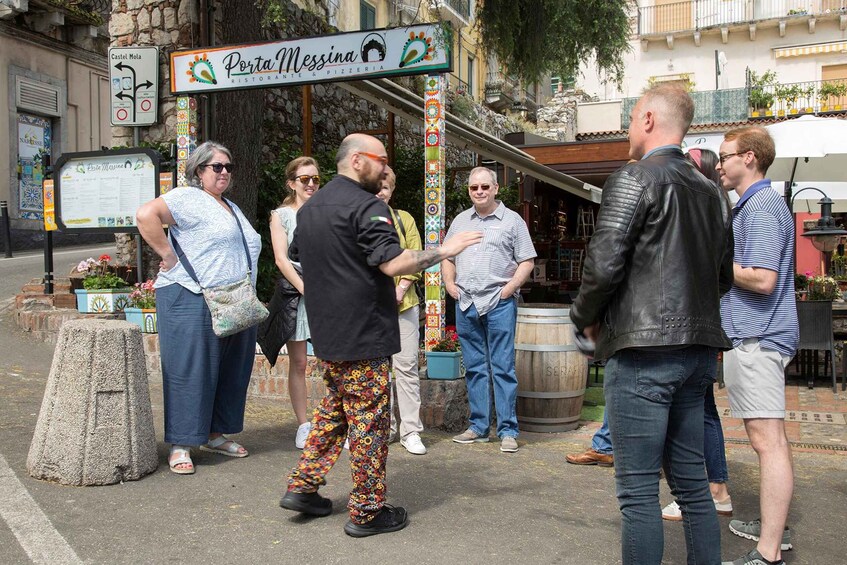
[337,79,602,203]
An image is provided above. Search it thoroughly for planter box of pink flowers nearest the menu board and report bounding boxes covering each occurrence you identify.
[74,254,131,313]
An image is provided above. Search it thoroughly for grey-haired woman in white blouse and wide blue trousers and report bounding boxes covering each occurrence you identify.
[136,141,262,475]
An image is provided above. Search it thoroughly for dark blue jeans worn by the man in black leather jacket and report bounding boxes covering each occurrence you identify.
[604,346,721,565]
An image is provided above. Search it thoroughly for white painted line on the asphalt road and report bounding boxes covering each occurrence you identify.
[0,455,82,564]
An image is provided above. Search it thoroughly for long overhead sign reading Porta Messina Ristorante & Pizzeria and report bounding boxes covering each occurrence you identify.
[171,24,452,94]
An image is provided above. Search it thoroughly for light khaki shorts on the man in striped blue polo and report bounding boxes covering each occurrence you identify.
[723,338,791,419]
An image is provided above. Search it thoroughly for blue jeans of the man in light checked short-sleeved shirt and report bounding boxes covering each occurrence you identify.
[456,298,518,438]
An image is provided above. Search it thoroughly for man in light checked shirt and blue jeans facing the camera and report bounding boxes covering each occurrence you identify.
[441,167,536,453]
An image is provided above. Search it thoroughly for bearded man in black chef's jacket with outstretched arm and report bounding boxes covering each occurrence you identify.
[280,134,482,537]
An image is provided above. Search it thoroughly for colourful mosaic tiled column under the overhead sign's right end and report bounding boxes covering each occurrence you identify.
[424,75,447,351]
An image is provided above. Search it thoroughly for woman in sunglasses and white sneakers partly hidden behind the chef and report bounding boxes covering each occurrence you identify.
[271,157,321,449]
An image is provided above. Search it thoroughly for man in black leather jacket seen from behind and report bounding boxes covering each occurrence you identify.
[570,85,732,565]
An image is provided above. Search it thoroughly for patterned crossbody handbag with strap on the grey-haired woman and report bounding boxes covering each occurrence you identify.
[170,199,268,337]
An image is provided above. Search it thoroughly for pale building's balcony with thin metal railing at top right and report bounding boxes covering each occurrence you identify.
[638,0,847,36]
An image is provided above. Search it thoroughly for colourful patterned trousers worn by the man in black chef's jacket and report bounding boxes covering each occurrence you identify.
[288,357,391,524]
